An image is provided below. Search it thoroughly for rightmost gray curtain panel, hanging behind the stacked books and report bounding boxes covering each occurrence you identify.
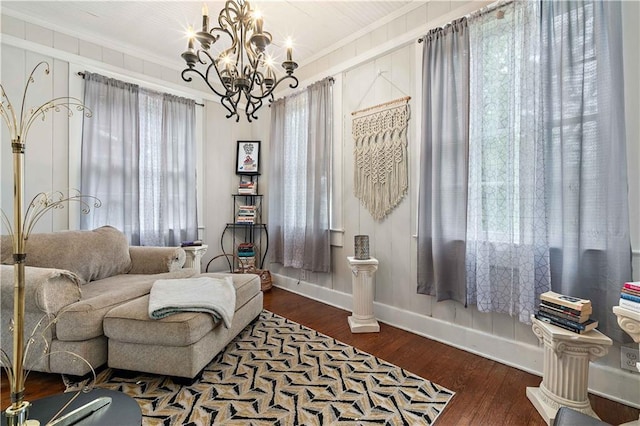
[540,1,632,341]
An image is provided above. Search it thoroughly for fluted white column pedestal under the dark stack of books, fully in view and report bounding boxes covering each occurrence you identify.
[527,318,613,425]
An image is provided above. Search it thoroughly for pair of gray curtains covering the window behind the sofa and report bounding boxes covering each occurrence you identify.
[81,73,197,246]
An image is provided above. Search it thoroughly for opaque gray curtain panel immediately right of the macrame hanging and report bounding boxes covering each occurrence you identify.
[417,18,469,305]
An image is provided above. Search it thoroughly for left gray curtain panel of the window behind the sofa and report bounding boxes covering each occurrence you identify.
[80,72,140,245]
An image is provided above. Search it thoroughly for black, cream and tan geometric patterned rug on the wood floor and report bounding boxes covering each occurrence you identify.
[89,311,454,426]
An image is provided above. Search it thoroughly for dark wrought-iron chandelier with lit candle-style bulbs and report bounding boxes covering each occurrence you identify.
[181,0,298,122]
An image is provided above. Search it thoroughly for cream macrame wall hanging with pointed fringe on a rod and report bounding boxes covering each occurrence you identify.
[351,96,411,220]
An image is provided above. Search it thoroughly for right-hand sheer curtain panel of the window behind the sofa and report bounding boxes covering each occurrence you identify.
[140,89,198,246]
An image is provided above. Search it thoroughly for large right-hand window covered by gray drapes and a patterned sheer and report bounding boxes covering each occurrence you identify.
[418,1,631,336]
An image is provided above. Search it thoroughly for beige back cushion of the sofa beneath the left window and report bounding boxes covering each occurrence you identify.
[2,226,131,282]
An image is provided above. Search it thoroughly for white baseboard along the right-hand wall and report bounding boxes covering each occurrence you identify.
[274,275,640,409]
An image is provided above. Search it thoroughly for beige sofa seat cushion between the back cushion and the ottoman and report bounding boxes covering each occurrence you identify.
[56,269,196,341]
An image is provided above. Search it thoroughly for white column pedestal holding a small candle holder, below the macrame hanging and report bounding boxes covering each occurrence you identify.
[347,257,380,333]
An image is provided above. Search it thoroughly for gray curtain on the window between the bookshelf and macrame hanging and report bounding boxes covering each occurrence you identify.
[268,79,333,272]
